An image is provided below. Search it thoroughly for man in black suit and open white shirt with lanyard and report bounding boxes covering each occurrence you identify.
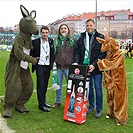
[31,26,54,112]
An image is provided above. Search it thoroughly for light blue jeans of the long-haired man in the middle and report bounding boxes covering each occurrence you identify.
[56,69,69,103]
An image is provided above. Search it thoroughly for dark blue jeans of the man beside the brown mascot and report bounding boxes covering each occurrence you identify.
[88,74,103,111]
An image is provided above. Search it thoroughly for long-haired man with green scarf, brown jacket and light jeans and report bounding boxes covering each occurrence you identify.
[52,24,75,108]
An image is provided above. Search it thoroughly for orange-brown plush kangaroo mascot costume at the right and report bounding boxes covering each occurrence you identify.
[97,34,128,125]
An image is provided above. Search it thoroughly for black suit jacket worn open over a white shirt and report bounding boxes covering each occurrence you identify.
[30,38,54,72]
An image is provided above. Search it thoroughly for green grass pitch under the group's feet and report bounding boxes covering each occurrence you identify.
[0,51,133,133]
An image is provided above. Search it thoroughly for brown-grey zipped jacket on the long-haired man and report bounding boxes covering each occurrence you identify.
[55,38,75,70]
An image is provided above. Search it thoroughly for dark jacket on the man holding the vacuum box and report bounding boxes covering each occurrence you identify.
[74,31,106,75]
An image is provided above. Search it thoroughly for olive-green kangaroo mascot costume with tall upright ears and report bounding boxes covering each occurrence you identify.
[3,5,39,118]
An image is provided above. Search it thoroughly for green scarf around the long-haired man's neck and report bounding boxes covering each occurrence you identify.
[54,35,74,53]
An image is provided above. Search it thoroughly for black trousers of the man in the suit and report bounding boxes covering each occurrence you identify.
[36,65,50,107]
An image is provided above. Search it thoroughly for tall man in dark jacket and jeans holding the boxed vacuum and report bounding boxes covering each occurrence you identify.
[73,19,106,118]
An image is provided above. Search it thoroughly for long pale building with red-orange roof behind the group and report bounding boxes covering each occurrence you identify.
[49,9,133,39]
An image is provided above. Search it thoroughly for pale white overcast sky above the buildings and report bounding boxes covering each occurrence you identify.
[0,0,133,27]
